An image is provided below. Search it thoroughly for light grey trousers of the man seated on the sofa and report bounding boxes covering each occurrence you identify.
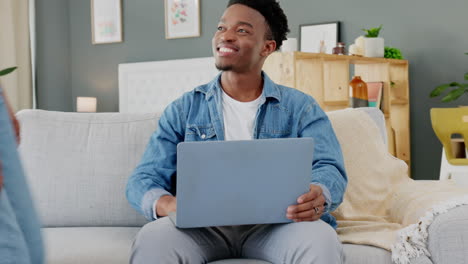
[130,217,343,264]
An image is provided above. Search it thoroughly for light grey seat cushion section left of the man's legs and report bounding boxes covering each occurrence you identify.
[42,227,140,264]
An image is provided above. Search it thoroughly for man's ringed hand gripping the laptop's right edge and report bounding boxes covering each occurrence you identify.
[286,184,325,222]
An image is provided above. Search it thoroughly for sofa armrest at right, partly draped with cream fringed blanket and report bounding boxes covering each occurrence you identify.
[390,180,468,264]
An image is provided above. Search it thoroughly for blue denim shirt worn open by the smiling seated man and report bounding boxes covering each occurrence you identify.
[126,73,347,228]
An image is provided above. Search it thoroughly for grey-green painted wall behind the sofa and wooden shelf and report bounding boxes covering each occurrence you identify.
[36,0,468,179]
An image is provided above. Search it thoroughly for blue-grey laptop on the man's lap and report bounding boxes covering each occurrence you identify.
[169,138,314,228]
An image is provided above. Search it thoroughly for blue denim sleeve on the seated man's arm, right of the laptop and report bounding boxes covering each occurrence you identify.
[299,98,348,212]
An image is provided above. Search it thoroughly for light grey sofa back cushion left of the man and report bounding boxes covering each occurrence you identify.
[17,110,159,227]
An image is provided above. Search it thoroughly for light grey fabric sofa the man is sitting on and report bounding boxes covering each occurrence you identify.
[17,110,468,264]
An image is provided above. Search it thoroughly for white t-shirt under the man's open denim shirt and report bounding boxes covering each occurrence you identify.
[222,90,261,140]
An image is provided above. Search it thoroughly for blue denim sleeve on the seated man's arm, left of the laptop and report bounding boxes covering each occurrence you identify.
[126,100,185,221]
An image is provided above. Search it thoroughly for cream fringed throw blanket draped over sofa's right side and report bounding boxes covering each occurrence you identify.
[328,109,468,263]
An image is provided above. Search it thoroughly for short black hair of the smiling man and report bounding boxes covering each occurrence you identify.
[227,0,289,50]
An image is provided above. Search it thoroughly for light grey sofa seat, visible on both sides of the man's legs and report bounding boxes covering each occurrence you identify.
[42,227,392,264]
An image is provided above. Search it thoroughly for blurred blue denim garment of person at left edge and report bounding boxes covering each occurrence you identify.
[0,87,45,264]
